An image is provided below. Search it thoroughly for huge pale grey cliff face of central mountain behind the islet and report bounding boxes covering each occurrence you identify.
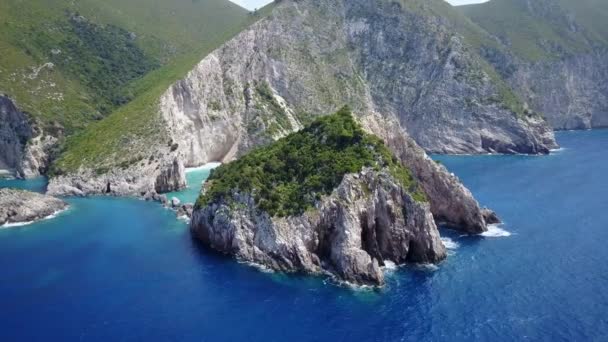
[161,0,556,165]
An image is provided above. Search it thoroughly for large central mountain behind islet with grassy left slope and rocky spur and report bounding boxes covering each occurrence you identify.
[49,0,524,231]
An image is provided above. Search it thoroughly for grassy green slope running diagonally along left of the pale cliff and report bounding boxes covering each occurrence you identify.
[52,4,274,174]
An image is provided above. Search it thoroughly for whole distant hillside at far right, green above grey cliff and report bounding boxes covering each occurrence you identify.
[459,0,608,129]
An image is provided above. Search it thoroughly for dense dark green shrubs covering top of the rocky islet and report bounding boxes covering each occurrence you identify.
[196,107,426,217]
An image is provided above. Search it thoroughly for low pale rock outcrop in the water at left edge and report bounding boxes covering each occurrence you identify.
[0,189,68,226]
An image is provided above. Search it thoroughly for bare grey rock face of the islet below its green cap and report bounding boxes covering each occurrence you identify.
[191,170,446,285]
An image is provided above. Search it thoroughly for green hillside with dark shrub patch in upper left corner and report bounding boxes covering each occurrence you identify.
[0,0,253,134]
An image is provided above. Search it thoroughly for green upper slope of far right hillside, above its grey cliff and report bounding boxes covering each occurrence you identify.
[458,0,608,61]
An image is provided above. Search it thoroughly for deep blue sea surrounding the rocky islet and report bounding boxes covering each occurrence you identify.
[0,130,608,341]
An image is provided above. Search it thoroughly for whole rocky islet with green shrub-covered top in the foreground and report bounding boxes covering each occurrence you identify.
[191,108,446,285]
